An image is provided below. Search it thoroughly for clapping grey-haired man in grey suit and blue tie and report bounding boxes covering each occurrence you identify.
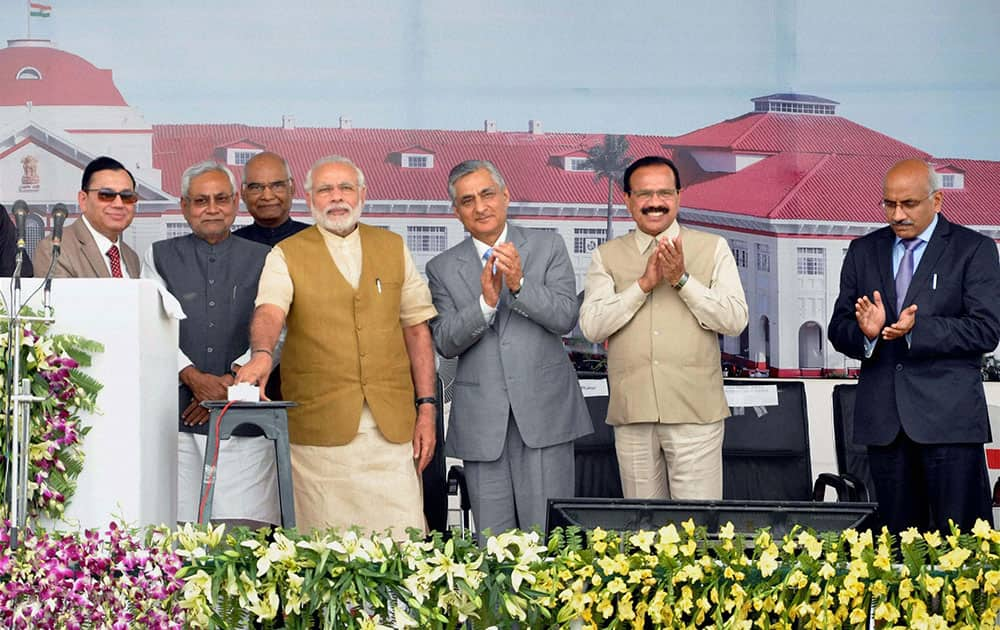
[427,160,593,533]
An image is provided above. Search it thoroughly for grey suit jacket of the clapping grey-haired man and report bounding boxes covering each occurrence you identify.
[426,223,593,461]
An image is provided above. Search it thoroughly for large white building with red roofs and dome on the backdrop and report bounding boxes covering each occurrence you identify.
[0,40,1000,376]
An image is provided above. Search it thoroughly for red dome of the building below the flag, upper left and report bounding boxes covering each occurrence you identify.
[0,39,128,107]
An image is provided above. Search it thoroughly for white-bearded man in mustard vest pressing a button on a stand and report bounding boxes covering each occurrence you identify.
[236,156,438,538]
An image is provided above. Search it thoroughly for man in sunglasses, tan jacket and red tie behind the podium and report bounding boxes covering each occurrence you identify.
[34,156,139,278]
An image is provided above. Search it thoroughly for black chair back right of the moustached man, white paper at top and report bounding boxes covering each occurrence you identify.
[722,379,812,501]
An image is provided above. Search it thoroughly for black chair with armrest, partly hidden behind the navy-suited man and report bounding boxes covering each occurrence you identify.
[813,383,878,503]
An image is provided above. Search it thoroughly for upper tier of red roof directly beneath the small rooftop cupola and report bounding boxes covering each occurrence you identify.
[666,112,930,158]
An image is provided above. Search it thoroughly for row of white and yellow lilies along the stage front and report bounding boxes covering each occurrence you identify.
[170,521,1000,629]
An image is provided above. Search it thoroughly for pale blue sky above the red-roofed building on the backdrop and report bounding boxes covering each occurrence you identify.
[0,0,1000,160]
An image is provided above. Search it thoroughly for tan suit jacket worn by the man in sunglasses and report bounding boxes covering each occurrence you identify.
[33,218,139,278]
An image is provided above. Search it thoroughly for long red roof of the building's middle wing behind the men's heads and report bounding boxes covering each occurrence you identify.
[153,124,670,204]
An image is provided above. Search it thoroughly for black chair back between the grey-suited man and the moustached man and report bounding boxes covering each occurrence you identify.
[573,372,622,498]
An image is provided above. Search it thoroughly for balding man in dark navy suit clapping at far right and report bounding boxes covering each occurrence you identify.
[829,160,1000,532]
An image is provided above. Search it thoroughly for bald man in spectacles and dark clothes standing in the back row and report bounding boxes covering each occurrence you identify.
[233,152,309,247]
